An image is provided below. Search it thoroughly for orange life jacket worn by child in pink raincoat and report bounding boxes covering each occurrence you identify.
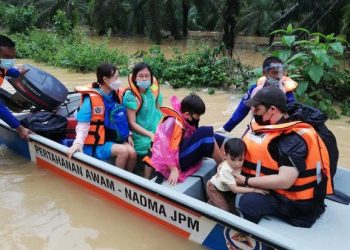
[160,107,185,149]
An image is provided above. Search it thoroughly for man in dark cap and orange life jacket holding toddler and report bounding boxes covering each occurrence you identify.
[234,86,333,227]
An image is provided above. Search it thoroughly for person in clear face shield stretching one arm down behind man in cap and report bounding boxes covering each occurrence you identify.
[216,56,298,133]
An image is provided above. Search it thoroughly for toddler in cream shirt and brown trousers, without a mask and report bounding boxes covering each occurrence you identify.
[207,138,267,211]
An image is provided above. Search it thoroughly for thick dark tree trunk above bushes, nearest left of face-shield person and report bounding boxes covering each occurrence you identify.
[222,0,239,57]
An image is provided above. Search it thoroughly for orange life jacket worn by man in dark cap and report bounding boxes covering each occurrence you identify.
[242,121,333,200]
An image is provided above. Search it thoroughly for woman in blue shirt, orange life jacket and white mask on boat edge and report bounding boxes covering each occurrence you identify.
[67,63,136,172]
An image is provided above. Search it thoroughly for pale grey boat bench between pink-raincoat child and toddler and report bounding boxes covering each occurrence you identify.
[152,158,216,201]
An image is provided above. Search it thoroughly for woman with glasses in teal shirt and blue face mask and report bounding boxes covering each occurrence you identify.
[123,63,162,179]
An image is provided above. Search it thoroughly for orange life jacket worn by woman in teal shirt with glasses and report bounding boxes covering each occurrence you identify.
[117,74,160,112]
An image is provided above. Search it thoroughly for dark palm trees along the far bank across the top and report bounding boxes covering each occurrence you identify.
[0,0,350,55]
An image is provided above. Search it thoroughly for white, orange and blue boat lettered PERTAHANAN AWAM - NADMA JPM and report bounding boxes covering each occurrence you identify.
[0,65,350,250]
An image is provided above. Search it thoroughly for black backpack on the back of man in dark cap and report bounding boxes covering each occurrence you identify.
[288,103,339,183]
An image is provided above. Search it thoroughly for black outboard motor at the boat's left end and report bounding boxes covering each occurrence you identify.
[2,64,68,112]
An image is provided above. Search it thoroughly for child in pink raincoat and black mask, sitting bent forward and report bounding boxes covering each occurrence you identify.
[144,94,224,185]
